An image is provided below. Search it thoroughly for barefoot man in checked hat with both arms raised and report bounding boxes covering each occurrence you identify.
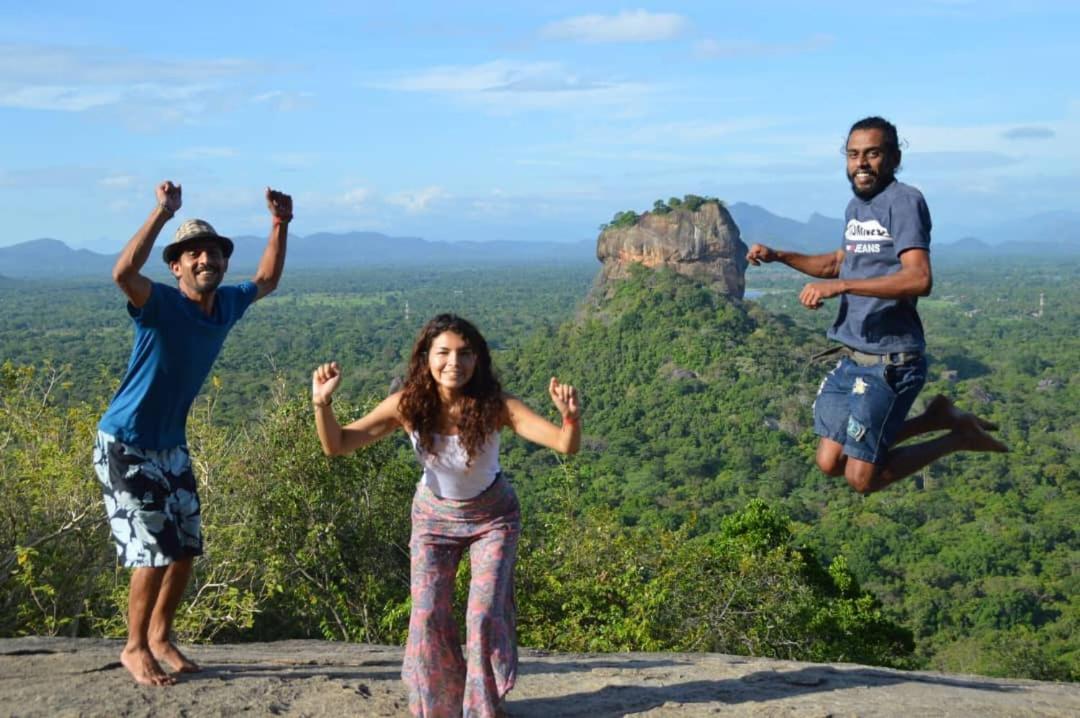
[94,181,293,686]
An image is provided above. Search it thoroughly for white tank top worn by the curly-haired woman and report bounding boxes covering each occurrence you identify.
[409,431,502,501]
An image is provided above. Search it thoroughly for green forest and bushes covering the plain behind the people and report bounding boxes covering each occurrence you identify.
[0,254,1080,680]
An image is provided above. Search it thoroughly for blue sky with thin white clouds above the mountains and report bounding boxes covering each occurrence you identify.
[0,0,1080,252]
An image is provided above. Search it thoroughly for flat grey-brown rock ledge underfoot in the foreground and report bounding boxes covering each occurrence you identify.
[0,637,1080,718]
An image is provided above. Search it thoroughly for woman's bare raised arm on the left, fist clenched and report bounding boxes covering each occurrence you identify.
[311,362,402,457]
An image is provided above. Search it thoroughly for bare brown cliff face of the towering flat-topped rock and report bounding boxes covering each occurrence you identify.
[596,202,747,299]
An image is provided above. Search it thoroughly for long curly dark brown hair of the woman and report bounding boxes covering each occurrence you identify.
[397,314,505,464]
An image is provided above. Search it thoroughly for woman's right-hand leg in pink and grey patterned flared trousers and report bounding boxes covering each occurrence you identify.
[463,521,521,718]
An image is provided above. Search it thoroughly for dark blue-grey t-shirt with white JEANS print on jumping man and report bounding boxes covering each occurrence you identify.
[828,180,930,354]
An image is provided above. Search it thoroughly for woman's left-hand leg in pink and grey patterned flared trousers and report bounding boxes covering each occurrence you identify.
[402,520,465,717]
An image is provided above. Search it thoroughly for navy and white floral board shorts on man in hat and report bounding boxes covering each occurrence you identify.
[94,431,202,568]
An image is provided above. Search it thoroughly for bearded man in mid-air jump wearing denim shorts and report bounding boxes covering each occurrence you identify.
[746,117,1008,493]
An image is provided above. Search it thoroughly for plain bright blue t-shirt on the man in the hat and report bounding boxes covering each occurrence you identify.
[98,282,258,449]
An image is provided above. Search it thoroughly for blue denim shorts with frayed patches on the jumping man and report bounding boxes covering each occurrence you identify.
[813,356,927,464]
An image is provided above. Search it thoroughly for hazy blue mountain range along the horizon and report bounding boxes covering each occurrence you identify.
[0,202,1080,282]
